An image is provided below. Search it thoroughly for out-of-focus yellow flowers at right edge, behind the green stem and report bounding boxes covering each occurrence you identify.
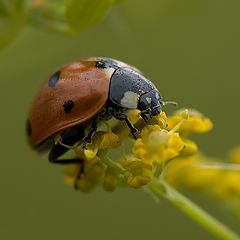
[163,148,240,203]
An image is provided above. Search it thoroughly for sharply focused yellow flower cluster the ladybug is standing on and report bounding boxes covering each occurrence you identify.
[65,110,212,192]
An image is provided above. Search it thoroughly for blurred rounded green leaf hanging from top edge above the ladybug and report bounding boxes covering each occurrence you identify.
[66,0,115,31]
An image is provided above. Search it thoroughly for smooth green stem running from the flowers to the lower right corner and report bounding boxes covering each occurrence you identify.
[148,180,240,240]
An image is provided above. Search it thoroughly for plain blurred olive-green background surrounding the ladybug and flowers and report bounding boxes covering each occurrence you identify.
[0,0,240,240]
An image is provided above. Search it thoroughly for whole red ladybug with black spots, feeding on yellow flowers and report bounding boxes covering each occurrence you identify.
[26,57,174,164]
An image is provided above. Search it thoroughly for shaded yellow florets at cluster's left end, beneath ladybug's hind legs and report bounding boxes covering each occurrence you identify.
[65,131,122,192]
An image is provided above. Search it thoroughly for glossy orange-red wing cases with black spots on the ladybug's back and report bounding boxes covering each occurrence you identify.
[27,58,139,148]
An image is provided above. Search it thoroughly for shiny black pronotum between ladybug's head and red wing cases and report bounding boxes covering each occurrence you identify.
[109,68,156,106]
